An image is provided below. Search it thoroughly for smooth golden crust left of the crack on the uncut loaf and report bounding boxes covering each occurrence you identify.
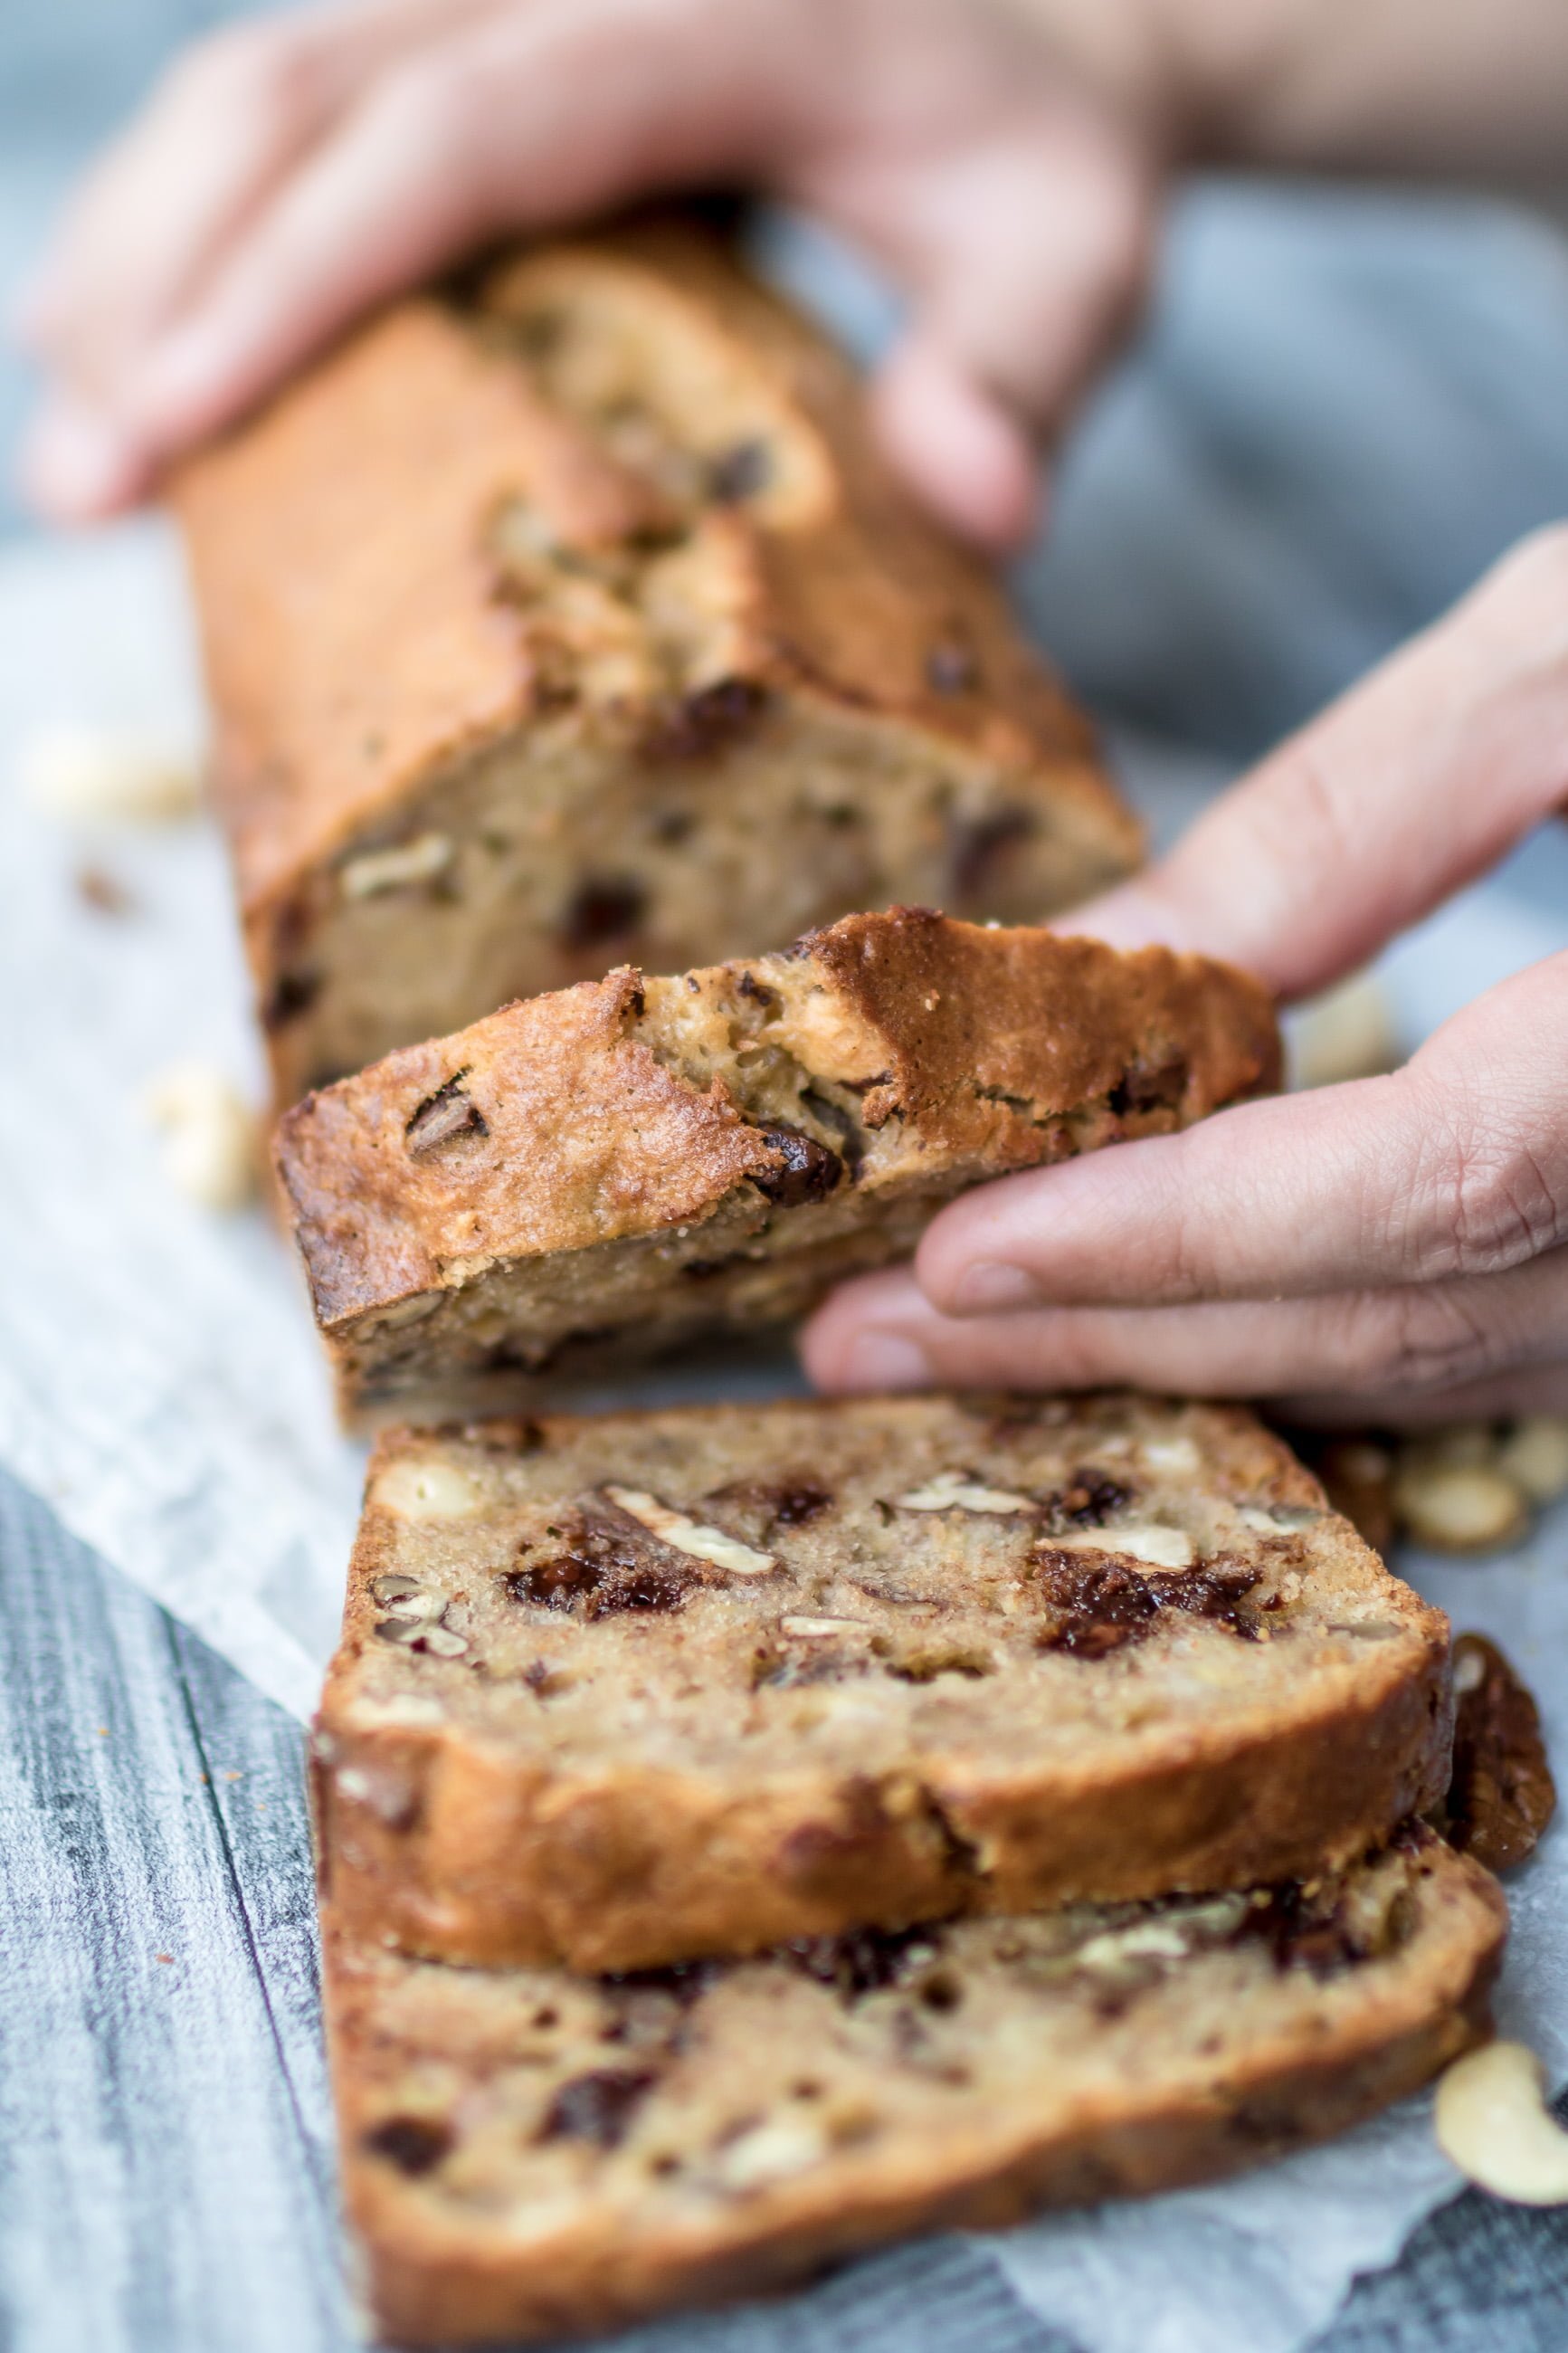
[174,299,649,927]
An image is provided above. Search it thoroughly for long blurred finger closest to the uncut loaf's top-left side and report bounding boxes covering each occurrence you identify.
[93,0,771,472]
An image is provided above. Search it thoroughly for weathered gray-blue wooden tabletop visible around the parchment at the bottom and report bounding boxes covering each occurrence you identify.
[0,1475,1568,2353]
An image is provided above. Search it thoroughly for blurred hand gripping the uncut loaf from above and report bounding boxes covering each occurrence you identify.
[21,0,1159,546]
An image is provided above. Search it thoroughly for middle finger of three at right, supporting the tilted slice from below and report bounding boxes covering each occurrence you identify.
[917,953,1568,1315]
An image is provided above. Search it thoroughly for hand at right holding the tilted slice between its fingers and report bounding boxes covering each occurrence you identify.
[804,527,1568,1424]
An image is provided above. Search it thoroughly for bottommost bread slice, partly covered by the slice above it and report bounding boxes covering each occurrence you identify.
[327,1831,1506,2346]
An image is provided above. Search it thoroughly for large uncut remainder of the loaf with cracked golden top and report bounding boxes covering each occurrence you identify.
[176,221,1140,1106]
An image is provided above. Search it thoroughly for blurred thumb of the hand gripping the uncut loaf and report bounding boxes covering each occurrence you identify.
[860,119,1156,548]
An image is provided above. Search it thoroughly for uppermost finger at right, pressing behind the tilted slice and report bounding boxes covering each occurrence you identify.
[1074,525,1568,997]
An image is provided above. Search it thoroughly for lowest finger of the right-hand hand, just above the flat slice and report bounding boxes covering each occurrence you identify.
[802,1252,1568,1409]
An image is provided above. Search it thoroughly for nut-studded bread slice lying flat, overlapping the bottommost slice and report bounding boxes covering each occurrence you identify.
[315,1397,1453,1969]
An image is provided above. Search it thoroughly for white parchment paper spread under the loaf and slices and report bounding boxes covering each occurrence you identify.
[0,525,1568,2353]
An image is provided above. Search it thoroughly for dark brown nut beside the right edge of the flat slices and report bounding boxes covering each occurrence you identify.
[1439,1633,1556,1871]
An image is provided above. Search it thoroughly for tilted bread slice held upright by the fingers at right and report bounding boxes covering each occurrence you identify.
[278,909,1278,1421]
